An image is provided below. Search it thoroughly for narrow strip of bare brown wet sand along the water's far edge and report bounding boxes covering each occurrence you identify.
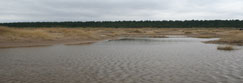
[0,35,217,49]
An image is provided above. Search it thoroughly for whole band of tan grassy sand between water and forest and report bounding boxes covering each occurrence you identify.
[0,27,243,48]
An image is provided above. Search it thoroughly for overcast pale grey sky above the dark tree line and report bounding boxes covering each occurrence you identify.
[0,0,243,22]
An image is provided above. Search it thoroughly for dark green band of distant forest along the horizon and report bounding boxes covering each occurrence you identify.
[0,20,243,28]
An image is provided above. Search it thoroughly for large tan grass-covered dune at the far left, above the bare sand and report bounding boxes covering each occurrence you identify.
[0,27,96,41]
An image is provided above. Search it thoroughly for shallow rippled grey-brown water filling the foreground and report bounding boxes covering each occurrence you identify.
[0,37,243,83]
